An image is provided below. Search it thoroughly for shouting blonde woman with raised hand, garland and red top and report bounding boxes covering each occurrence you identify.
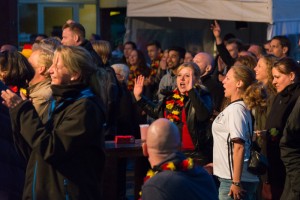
[133,62,212,165]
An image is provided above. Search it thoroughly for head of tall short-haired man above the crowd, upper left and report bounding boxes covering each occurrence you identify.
[61,22,85,46]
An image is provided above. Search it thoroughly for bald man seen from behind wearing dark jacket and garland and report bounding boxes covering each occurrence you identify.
[142,118,218,200]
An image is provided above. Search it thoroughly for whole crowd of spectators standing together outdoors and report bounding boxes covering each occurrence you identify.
[0,20,300,200]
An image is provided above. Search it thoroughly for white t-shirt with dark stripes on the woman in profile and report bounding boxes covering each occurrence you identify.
[212,101,259,182]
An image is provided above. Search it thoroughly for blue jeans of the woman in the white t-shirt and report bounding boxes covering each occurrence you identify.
[219,178,258,200]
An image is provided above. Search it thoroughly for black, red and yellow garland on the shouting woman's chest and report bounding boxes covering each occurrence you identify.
[166,89,184,122]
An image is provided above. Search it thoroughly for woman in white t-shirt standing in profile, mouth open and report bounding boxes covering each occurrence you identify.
[212,65,259,200]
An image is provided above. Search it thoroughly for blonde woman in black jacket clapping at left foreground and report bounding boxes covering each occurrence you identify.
[1,46,105,200]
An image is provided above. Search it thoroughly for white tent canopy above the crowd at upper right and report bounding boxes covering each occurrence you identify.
[127,0,300,39]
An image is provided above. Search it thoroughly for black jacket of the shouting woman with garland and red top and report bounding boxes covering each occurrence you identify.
[137,86,212,162]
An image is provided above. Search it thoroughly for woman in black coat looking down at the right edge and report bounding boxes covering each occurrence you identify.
[265,57,300,199]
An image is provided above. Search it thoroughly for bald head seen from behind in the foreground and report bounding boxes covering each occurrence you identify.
[143,118,181,166]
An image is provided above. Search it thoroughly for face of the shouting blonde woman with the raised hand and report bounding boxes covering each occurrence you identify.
[177,67,194,94]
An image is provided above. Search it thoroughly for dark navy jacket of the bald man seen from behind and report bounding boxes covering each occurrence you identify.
[142,152,218,200]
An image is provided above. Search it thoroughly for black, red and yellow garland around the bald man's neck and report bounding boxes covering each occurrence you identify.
[140,158,194,199]
